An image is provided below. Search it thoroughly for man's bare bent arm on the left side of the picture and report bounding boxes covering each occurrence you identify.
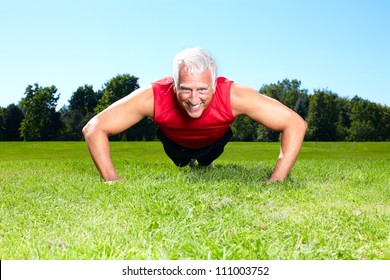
[83,86,154,182]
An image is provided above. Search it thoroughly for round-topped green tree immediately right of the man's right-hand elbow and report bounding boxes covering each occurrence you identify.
[307,90,338,141]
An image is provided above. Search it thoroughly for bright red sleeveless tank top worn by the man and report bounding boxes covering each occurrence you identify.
[152,77,235,149]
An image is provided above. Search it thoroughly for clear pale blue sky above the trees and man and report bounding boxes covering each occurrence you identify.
[0,0,390,107]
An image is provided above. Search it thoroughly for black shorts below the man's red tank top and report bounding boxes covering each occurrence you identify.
[157,127,233,167]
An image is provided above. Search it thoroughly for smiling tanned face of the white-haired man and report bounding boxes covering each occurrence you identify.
[176,69,213,119]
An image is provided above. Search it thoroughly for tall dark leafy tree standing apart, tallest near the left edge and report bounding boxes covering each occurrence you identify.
[20,84,63,141]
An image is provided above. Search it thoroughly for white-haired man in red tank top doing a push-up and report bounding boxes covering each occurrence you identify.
[83,48,307,183]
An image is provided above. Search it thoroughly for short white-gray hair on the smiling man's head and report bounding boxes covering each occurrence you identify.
[173,48,217,90]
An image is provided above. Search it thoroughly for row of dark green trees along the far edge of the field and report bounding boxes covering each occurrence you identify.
[0,74,390,142]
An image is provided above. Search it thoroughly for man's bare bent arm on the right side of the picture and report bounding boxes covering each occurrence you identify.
[231,84,307,183]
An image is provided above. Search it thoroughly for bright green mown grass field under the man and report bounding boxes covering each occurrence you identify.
[0,142,390,260]
